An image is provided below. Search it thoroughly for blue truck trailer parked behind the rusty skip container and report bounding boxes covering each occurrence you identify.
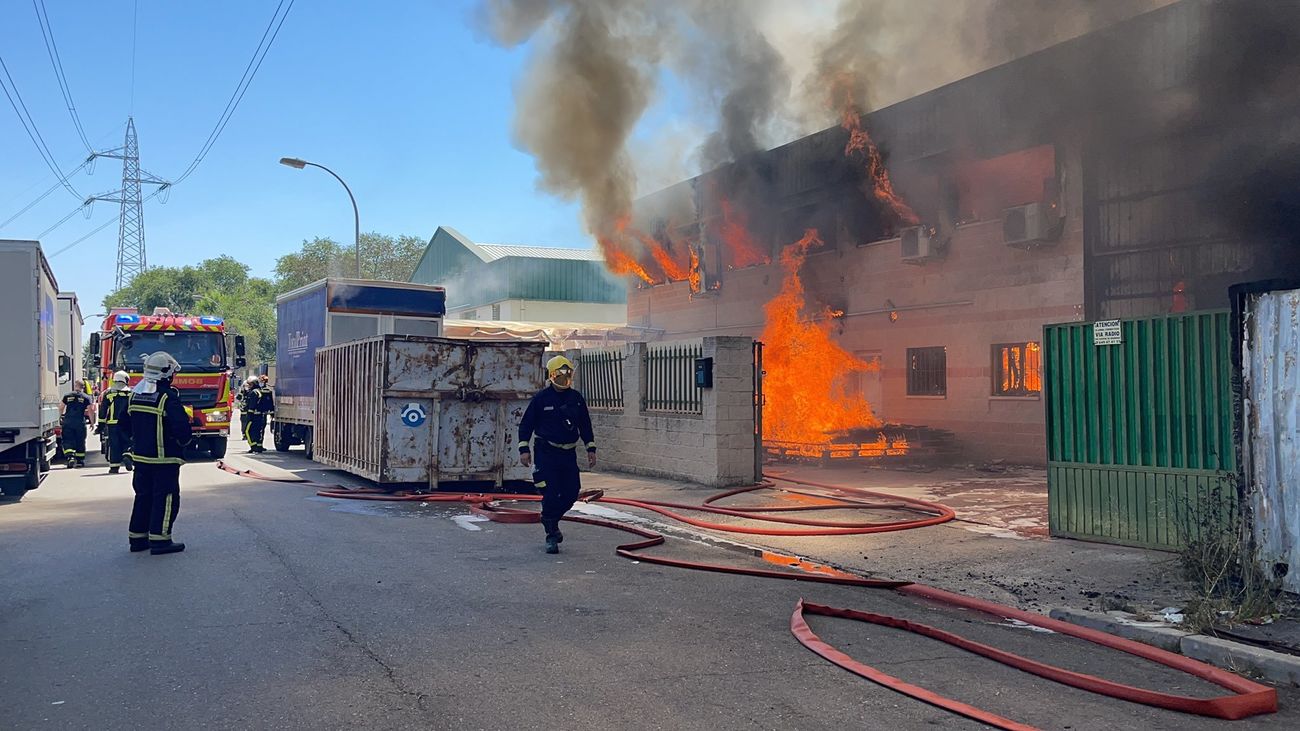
[270,278,447,458]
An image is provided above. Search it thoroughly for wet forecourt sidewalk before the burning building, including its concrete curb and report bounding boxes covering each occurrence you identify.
[582,466,1300,685]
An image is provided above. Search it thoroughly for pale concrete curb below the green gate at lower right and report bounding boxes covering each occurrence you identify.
[1049,607,1300,687]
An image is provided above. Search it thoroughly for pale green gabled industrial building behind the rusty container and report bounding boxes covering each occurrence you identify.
[411,226,627,324]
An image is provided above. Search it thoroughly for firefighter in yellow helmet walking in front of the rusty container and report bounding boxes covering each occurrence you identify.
[519,355,595,553]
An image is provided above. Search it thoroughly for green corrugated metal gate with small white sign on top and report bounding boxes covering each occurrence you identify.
[1043,310,1236,550]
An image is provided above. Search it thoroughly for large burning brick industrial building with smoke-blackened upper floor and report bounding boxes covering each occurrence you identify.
[627,0,1300,464]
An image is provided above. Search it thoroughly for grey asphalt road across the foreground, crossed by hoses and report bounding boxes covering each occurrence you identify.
[0,434,1300,731]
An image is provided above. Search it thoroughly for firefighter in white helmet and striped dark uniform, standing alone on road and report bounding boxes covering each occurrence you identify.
[122,352,191,555]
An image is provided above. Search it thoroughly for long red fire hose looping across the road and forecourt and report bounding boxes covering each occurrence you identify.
[217,462,1278,731]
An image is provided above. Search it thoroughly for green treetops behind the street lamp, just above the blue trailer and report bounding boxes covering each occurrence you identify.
[276,233,426,294]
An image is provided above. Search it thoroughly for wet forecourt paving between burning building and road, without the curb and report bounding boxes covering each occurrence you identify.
[582,466,1188,614]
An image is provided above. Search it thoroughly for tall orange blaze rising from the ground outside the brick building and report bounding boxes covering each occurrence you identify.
[763,229,880,444]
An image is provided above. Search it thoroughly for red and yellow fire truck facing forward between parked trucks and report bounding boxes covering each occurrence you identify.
[91,307,246,459]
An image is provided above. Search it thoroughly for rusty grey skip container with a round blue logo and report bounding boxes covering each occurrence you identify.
[315,336,545,488]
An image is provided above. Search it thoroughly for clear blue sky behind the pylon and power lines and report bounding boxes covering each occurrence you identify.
[0,0,589,315]
